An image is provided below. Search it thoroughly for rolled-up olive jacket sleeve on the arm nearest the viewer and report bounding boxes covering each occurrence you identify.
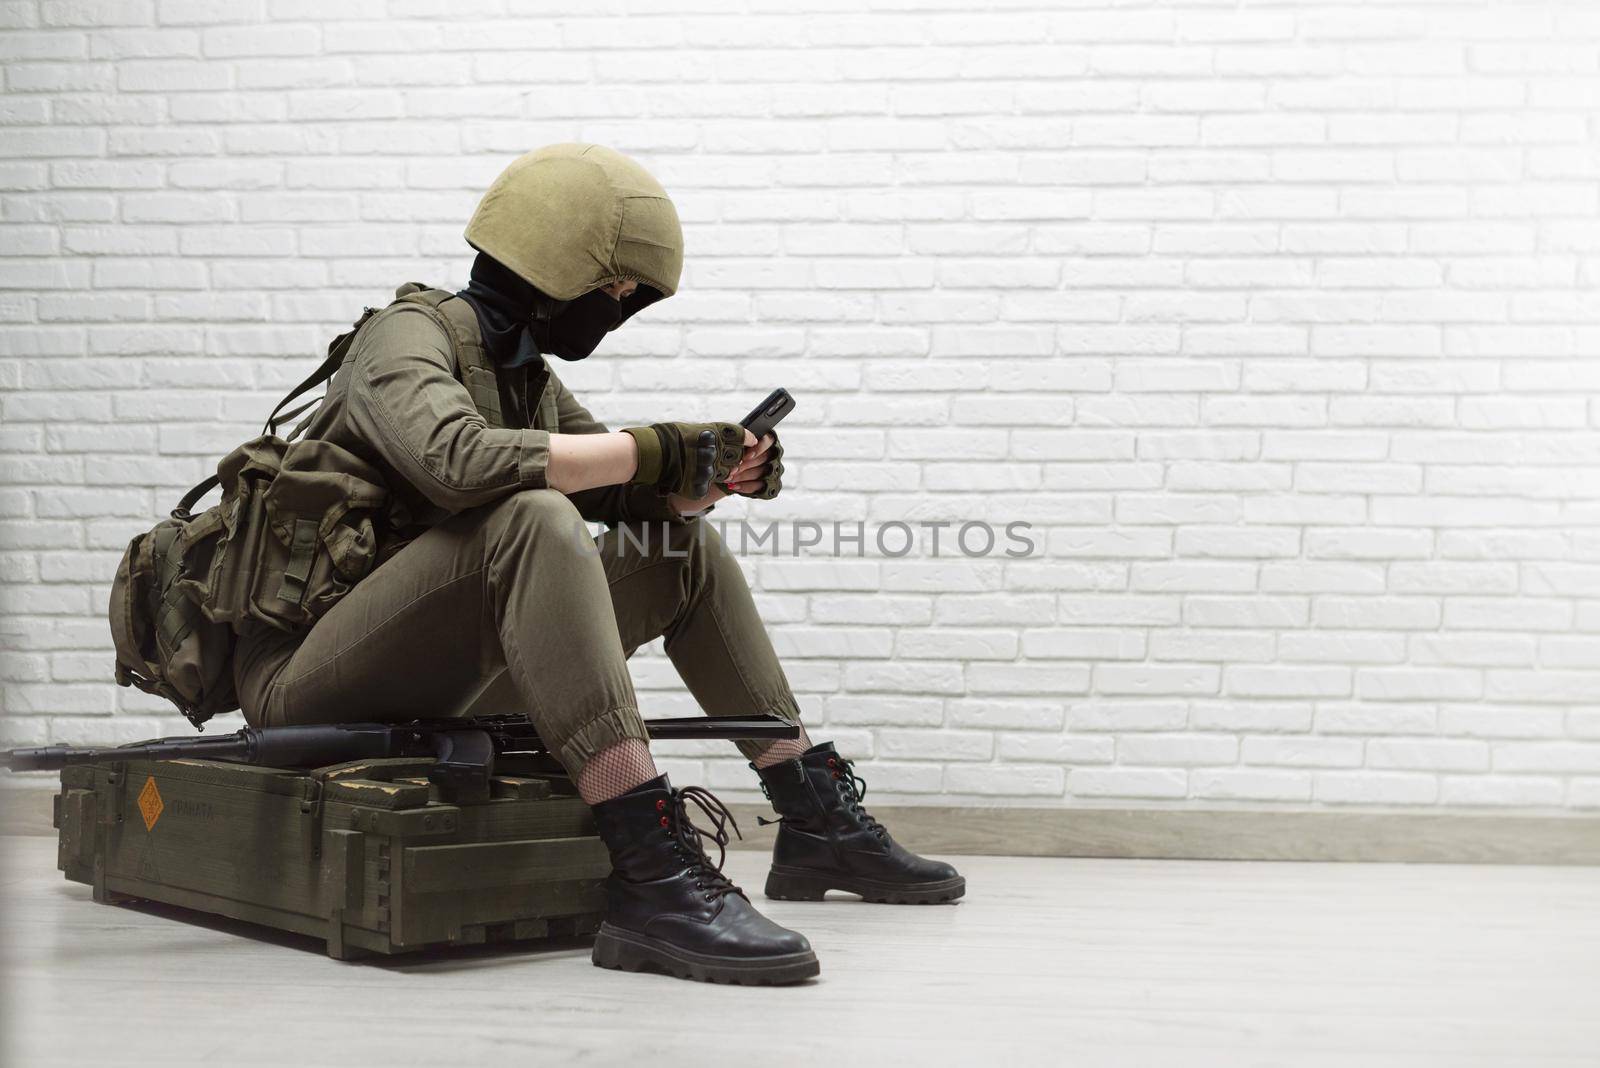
[347,309,550,512]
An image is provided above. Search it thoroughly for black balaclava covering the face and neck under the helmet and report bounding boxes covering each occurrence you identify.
[458,253,661,368]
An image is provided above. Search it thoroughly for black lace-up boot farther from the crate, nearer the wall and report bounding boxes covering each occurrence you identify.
[752,742,966,905]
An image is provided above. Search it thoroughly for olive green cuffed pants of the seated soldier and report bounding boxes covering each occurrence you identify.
[234,489,800,779]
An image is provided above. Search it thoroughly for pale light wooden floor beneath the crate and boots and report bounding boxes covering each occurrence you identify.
[0,838,1600,1068]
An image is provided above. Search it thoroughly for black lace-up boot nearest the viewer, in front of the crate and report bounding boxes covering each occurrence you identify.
[594,775,821,985]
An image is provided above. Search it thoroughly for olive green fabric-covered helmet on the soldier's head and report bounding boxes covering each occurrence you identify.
[467,144,683,301]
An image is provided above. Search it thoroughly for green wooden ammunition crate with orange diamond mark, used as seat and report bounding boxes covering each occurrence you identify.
[54,758,611,959]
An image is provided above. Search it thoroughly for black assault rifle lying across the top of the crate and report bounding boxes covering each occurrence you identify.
[0,715,800,799]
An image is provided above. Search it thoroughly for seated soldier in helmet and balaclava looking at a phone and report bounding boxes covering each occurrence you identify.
[234,144,965,983]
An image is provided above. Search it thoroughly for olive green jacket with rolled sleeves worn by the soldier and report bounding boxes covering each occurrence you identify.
[306,283,678,537]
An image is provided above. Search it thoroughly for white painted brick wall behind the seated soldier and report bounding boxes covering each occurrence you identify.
[0,0,1600,809]
